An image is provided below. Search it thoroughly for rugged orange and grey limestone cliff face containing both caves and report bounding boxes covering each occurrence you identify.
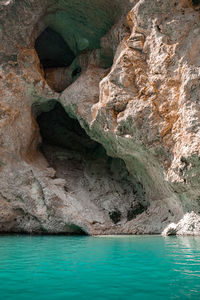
[0,0,200,234]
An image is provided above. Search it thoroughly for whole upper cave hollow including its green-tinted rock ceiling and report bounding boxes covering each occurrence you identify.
[34,0,119,93]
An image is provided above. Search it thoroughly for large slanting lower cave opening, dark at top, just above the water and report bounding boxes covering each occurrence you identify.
[36,100,148,224]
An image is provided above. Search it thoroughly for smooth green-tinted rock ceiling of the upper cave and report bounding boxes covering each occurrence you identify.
[44,0,118,55]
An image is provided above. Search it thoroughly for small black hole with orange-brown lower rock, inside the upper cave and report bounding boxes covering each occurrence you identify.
[35,27,81,93]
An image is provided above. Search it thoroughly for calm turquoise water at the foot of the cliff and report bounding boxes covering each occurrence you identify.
[0,236,200,300]
